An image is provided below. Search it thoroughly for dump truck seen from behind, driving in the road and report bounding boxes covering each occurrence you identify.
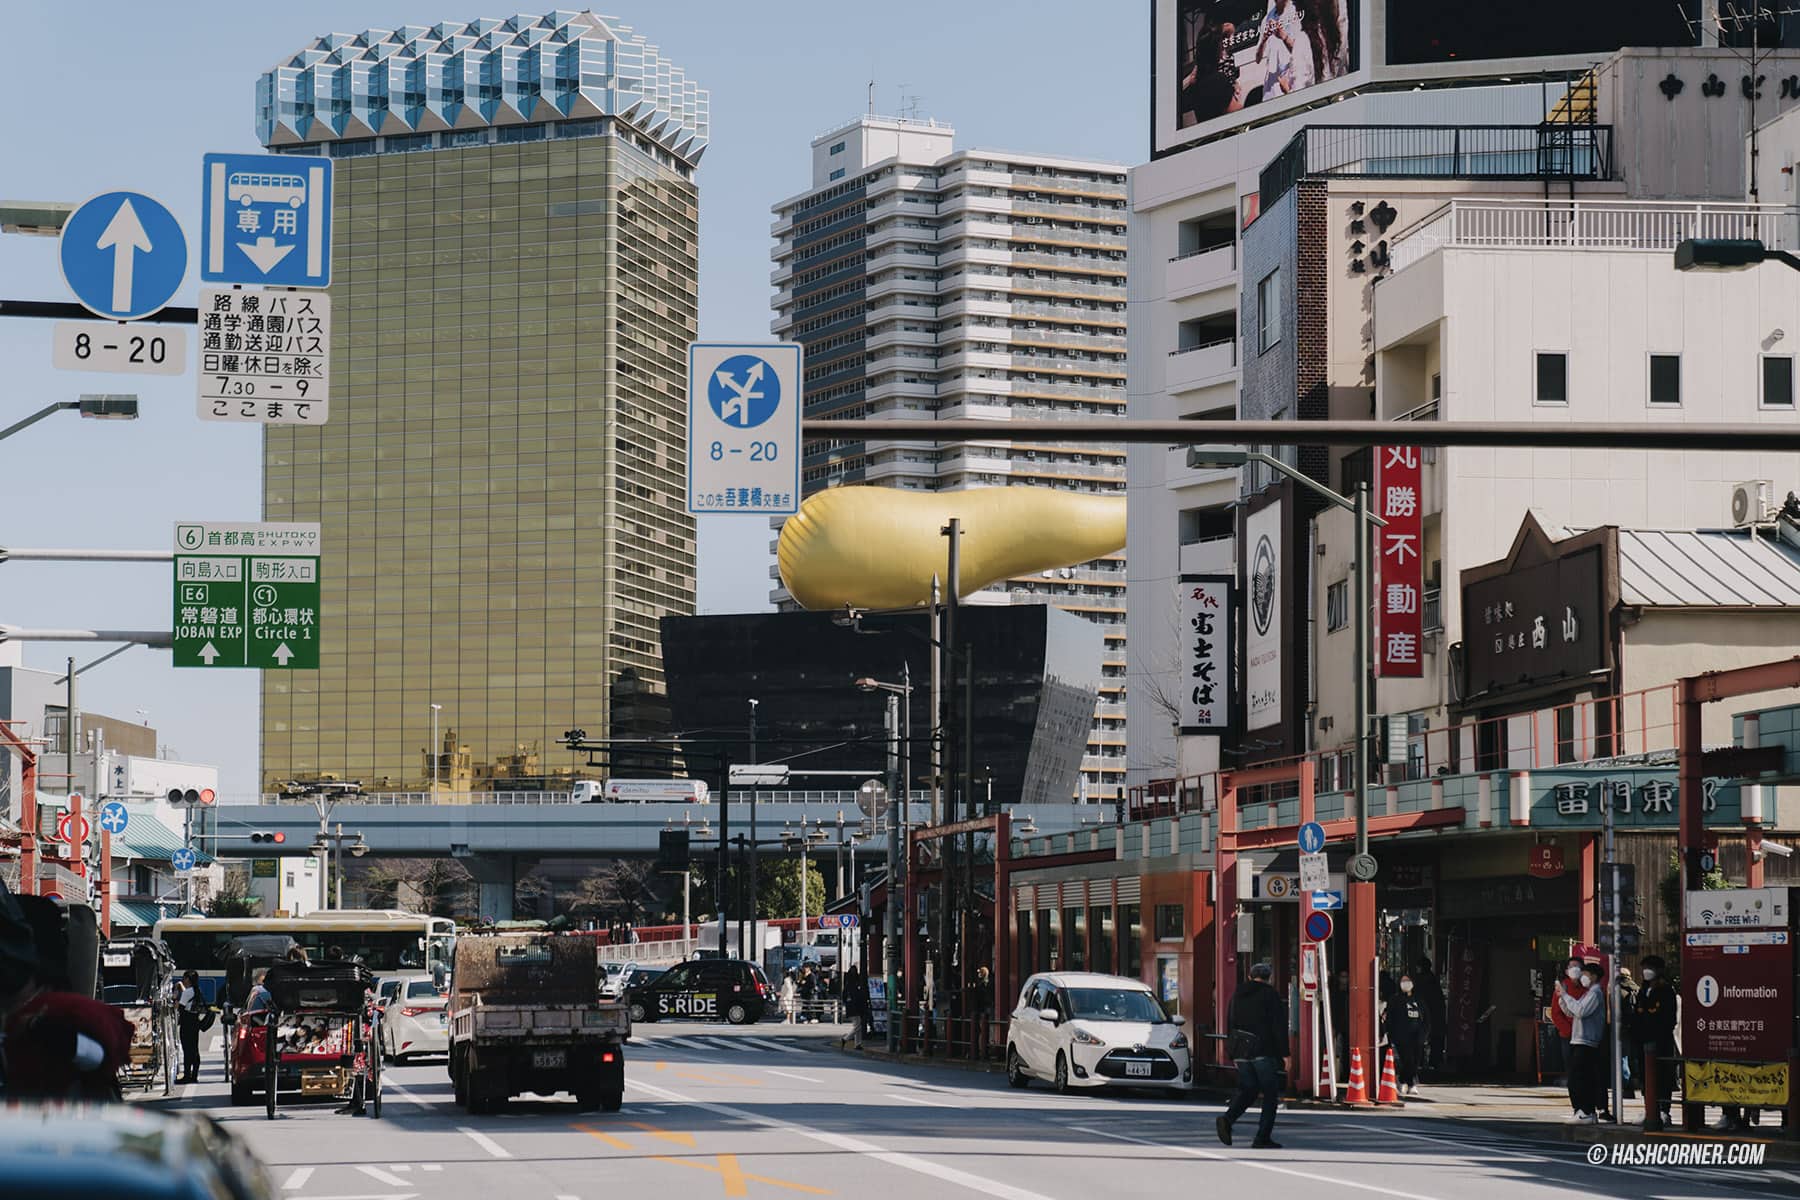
[450,932,632,1114]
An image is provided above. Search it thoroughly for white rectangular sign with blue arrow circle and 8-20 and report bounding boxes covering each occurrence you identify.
[688,342,801,516]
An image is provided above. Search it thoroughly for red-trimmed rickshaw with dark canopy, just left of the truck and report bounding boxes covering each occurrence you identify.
[230,963,382,1119]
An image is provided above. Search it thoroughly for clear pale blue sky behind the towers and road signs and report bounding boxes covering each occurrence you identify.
[0,0,1148,797]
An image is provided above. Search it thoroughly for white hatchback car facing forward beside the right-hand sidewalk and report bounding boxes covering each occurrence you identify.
[1006,972,1193,1094]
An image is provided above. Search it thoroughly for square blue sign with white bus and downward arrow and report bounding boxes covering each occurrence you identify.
[200,155,331,288]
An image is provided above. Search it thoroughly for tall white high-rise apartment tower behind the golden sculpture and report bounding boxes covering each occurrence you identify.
[770,115,1127,799]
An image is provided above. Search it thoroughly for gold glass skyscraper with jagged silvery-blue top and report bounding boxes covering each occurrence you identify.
[259,13,707,792]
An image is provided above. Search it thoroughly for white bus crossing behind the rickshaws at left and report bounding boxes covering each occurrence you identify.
[151,909,455,997]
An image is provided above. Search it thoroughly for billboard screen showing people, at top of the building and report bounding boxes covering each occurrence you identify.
[1152,0,1361,151]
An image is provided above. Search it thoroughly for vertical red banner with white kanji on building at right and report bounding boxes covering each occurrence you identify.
[1375,446,1426,678]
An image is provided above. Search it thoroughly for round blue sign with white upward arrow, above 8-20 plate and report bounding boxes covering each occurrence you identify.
[59,193,187,320]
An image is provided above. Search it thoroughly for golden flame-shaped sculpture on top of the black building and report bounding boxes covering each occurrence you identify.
[776,488,1125,610]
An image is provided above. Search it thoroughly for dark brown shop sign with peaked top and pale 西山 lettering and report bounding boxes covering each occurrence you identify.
[1462,516,1618,696]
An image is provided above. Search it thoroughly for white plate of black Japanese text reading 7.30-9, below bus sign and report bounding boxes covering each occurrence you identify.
[198,290,331,425]
